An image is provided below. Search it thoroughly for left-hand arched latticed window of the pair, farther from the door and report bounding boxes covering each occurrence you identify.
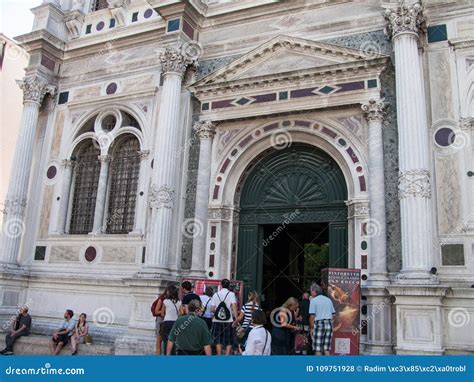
[69,139,100,234]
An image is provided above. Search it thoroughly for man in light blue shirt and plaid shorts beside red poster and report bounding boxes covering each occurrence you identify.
[309,283,336,355]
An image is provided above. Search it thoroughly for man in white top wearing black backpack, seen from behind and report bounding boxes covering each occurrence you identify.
[211,279,238,355]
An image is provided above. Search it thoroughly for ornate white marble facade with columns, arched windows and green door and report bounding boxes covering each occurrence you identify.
[0,0,474,354]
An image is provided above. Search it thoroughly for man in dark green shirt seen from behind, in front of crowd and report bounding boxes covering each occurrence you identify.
[166,300,213,355]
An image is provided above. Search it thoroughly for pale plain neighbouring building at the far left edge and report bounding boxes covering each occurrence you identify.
[0,33,28,230]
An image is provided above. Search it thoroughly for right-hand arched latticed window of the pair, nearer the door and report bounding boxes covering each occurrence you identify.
[106,134,140,233]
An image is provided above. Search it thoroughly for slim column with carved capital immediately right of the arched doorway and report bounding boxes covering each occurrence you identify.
[362,99,388,284]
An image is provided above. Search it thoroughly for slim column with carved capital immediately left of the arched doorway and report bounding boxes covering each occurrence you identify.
[191,121,216,276]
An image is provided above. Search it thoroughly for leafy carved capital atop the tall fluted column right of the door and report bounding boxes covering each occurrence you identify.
[383,3,426,39]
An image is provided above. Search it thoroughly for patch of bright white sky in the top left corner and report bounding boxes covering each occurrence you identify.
[0,0,42,38]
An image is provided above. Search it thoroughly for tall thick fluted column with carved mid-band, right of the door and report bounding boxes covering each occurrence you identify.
[384,4,433,283]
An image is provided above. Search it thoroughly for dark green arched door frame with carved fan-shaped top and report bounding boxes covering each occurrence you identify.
[237,144,348,291]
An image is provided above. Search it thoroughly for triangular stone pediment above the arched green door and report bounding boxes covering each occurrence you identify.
[194,36,385,87]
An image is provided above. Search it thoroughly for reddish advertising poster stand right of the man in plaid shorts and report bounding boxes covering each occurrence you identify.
[321,268,360,355]
